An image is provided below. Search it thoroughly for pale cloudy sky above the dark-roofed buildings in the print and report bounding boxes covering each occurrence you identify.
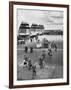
[17,9,63,30]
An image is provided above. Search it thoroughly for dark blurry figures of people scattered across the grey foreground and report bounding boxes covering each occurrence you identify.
[23,42,57,79]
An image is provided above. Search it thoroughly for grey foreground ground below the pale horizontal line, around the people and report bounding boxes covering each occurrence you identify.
[17,49,63,80]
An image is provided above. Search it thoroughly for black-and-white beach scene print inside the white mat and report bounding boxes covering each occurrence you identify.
[17,9,64,80]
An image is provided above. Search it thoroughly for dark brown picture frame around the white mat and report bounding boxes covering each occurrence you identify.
[9,1,69,88]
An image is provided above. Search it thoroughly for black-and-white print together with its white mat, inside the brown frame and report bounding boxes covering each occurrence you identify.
[9,1,68,88]
